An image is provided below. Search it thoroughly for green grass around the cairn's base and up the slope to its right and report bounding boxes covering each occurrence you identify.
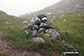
[0,12,84,56]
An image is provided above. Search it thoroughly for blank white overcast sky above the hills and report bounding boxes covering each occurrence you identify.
[0,0,61,16]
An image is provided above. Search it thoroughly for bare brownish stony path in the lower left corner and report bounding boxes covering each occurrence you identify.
[0,32,43,56]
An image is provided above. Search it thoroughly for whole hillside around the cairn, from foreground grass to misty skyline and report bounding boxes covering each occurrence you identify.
[0,0,84,56]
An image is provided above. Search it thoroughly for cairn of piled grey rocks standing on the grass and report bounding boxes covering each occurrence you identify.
[25,15,60,42]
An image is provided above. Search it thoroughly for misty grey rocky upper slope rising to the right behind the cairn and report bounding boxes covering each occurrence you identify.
[21,0,84,18]
